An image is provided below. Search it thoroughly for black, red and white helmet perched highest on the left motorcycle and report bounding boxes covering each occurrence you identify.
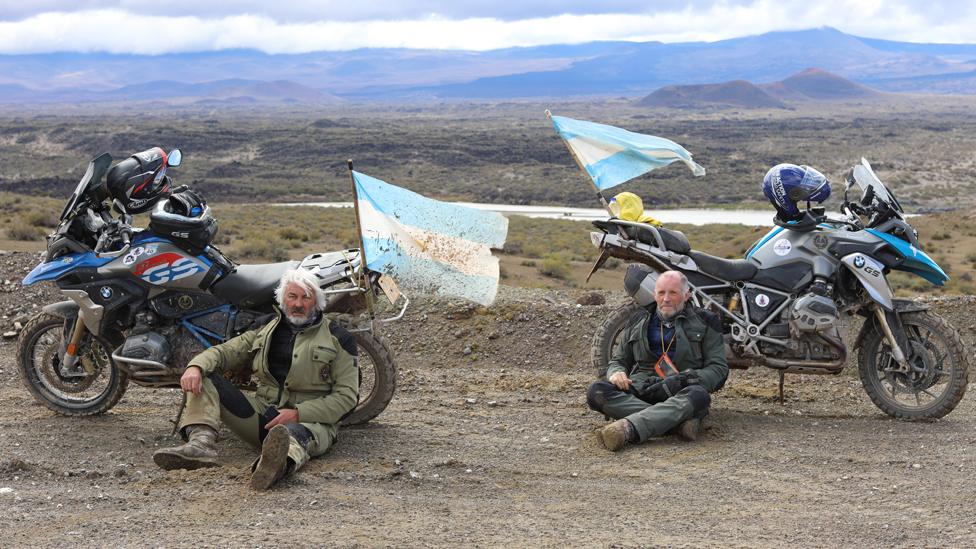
[105,147,172,214]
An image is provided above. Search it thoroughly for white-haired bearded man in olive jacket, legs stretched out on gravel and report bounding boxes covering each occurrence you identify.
[153,269,359,490]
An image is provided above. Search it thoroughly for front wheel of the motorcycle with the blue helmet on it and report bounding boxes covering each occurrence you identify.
[858,311,969,419]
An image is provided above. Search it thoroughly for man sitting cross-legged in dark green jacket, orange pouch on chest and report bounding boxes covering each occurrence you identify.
[586,265,729,451]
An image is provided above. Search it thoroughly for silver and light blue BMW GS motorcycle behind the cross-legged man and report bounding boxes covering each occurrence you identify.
[590,158,968,419]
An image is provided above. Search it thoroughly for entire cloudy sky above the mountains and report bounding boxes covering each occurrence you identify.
[0,0,976,54]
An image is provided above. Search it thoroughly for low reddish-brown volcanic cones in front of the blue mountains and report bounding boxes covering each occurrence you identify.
[638,68,884,109]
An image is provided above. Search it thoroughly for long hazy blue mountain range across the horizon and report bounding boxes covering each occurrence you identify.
[0,28,976,103]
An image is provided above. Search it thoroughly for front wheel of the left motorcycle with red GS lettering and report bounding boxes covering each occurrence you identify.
[17,313,129,416]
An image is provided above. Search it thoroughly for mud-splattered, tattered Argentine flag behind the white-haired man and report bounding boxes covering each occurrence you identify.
[352,171,508,305]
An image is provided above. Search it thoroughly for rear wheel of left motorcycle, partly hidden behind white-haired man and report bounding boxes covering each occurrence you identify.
[342,332,396,425]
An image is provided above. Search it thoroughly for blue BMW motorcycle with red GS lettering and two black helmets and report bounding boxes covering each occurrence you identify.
[17,148,409,425]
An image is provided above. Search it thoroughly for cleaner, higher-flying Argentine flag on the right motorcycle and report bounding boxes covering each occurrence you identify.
[552,116,705,191]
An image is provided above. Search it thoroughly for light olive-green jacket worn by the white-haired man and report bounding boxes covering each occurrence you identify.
[190,311,359,431]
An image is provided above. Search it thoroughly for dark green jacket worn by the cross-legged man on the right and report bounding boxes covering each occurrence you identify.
[607,303,729,393]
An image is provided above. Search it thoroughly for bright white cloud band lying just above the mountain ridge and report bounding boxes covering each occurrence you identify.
[0,0,976,54]
